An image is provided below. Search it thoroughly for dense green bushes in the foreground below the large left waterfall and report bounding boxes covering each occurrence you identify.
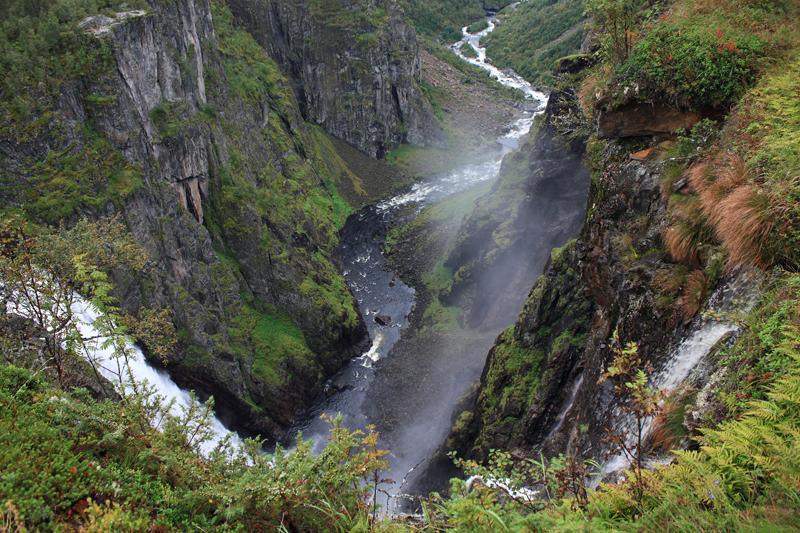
[0,363,385,531]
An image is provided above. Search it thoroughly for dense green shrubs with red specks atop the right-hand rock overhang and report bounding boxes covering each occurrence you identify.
[589,0,797,111]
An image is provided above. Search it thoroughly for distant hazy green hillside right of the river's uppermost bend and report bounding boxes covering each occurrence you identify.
[482,0,586,84]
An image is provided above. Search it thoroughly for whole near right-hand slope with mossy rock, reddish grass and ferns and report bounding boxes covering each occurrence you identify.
[446,1,800,531]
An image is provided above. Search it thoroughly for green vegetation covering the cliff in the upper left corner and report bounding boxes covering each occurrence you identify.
[0,0,144,223]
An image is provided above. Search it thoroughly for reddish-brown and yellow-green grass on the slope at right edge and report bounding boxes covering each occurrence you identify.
[666,54,800,269]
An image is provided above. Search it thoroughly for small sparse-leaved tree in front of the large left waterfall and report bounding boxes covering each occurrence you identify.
[0,217,174,395]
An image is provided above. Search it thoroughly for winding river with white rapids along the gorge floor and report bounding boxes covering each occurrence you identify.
[294,18,547,509]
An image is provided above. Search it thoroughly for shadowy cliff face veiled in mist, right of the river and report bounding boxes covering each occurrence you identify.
[445,92,589,327]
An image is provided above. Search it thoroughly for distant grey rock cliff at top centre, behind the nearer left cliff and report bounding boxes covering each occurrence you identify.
[225,0,439,158]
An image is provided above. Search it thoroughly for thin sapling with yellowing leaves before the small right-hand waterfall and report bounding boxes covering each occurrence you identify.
[600,331,664,505]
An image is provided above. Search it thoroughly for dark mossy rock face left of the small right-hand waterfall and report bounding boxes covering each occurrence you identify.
[458,103,696,457]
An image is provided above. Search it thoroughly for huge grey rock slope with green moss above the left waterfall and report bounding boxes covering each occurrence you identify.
[0,0,434,436]
